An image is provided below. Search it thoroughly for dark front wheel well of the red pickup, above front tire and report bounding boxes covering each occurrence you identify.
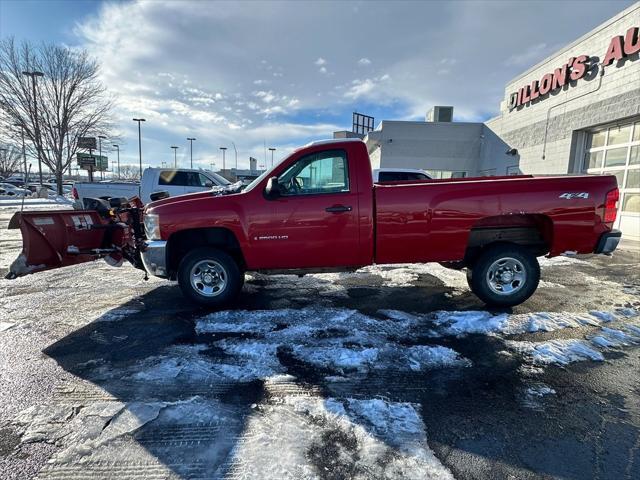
[167,227,245,278]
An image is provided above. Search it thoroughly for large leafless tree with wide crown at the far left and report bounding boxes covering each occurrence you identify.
[0,38,113,194]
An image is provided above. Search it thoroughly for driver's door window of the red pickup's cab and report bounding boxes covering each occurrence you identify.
[278,150,349,195]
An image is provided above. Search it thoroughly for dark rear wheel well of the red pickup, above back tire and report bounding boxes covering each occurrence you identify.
[464,215,553,265]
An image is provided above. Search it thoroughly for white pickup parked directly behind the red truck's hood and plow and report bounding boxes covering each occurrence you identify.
[73,168,231,204]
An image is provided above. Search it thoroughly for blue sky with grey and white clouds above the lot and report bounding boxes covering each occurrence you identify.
[0,0,633,170]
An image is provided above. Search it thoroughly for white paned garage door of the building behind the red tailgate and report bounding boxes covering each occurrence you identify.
[583,121,640,240]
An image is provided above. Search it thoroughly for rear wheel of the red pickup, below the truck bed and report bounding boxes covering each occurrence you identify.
[467,244,540,307]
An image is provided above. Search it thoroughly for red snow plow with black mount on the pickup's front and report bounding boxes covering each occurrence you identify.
[6,198,144,279]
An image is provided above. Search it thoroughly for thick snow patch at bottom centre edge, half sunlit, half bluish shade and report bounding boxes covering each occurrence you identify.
[229,397,453,479]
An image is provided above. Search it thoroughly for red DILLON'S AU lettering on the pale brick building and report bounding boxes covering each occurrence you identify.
[509,27,640,110]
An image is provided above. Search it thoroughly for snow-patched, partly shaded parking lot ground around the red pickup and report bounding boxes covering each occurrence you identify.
[0,205,640,480]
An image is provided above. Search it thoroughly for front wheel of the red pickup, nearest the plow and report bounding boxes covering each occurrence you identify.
[178,247,244,307]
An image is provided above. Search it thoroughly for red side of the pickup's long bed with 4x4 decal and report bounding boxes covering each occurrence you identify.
[374,175,616,263]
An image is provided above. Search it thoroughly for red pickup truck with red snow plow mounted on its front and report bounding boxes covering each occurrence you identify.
[9,140,620,306]
